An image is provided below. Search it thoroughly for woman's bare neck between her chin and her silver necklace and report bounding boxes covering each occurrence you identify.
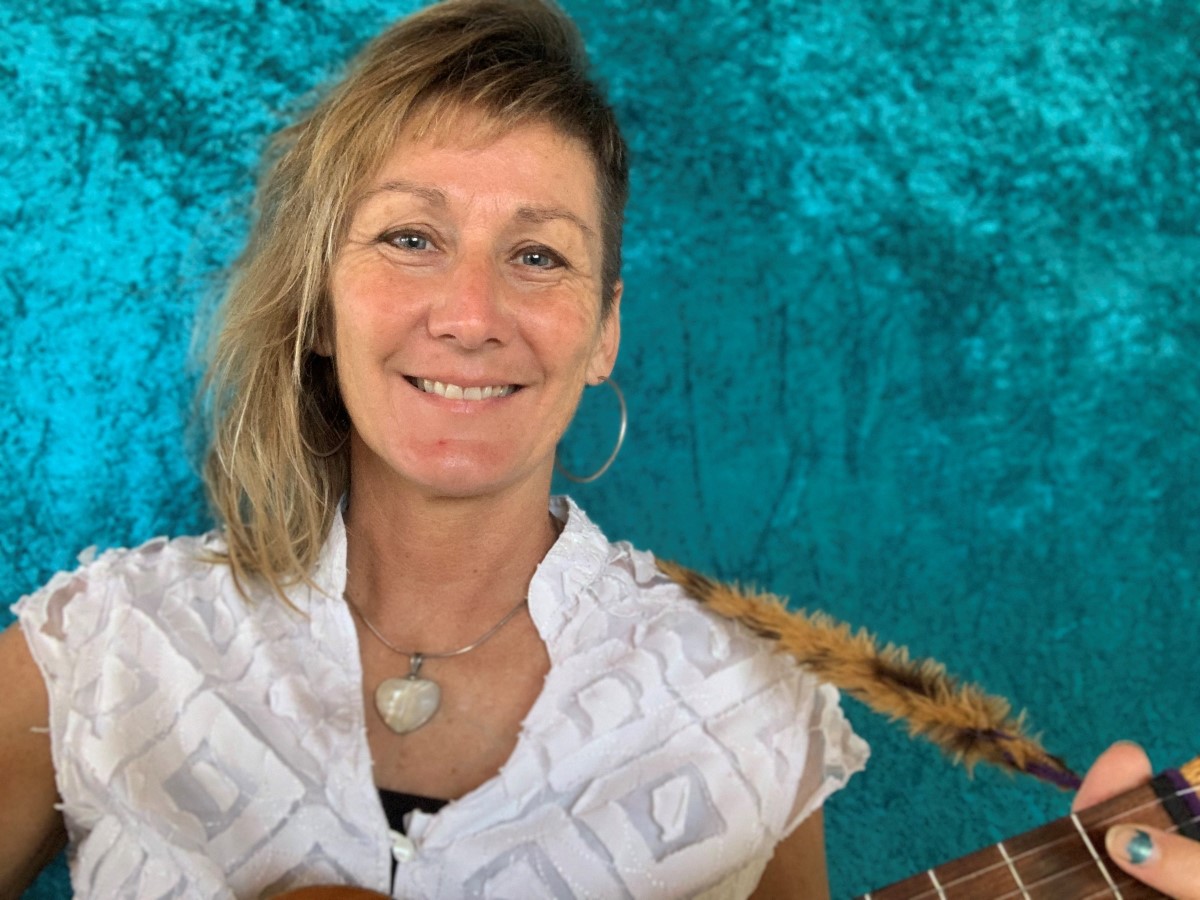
[346,468,558,650]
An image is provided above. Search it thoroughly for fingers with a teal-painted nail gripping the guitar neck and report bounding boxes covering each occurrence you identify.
[1072,742,1200,900]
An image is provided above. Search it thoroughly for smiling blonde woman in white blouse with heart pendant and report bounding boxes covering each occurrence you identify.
[0,0,1195,898]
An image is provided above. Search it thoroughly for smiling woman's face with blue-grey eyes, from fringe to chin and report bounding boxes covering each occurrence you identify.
[330,114,619,497]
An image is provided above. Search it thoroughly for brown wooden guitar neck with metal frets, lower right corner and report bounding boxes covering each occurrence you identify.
[858,757,1200,900]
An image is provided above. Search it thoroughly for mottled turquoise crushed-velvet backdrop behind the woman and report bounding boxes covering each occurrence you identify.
[0,0,1200,898]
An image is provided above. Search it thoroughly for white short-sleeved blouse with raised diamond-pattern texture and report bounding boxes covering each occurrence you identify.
[14,499,866,900]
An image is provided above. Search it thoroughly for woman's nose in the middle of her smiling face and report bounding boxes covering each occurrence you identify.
[428,258,512,350]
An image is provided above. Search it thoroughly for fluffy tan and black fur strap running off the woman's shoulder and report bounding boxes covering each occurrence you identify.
[658,559,1080,788]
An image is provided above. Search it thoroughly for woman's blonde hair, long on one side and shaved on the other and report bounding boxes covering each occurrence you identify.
[203,0,629,607]
